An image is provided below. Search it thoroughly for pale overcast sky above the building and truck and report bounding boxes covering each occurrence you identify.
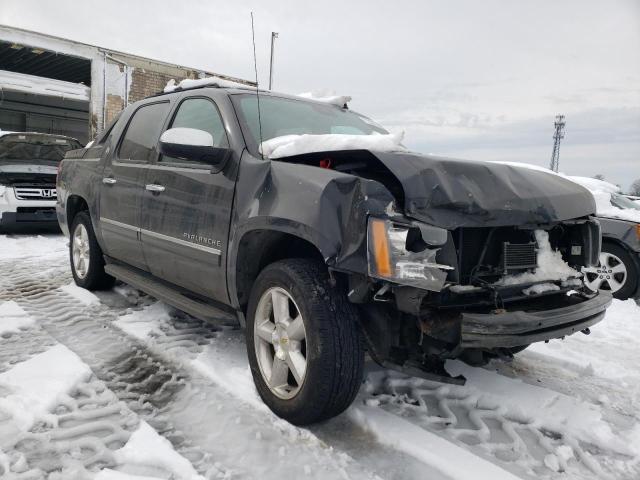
[0,0,640,188]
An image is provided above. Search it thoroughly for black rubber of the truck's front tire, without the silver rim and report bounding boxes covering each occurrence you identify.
[246,259,364,425]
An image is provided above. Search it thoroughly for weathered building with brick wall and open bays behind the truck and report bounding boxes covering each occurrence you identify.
[0,25,255,143]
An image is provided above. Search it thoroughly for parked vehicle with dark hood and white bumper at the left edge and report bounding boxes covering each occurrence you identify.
[0,132,82,231]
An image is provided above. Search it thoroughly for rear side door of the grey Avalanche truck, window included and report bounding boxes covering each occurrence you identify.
[99,101,170,270]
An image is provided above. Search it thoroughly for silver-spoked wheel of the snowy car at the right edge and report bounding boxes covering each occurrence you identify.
[582,242,638,300]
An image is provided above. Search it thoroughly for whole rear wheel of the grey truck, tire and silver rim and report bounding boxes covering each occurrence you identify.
[69,211,115,290]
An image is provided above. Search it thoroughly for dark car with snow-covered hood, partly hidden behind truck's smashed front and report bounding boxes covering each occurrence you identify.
[569,177,640,300]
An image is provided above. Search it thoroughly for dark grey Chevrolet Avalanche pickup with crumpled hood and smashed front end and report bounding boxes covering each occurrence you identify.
[57,82,611,424]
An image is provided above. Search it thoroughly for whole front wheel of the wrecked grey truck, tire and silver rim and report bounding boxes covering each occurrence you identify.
[246,259,364,425]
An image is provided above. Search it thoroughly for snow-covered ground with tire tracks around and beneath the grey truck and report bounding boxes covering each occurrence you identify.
[0,235,640,480]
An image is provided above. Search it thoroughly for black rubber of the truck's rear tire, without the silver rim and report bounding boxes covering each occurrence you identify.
[69,211,115,290]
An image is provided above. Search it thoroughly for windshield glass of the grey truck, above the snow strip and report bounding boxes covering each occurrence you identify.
[232,94,389,155]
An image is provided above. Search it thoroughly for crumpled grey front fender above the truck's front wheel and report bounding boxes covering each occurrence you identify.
[227,151,395,306]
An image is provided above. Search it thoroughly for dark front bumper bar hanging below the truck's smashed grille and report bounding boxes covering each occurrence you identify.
[460,292,612,349]
